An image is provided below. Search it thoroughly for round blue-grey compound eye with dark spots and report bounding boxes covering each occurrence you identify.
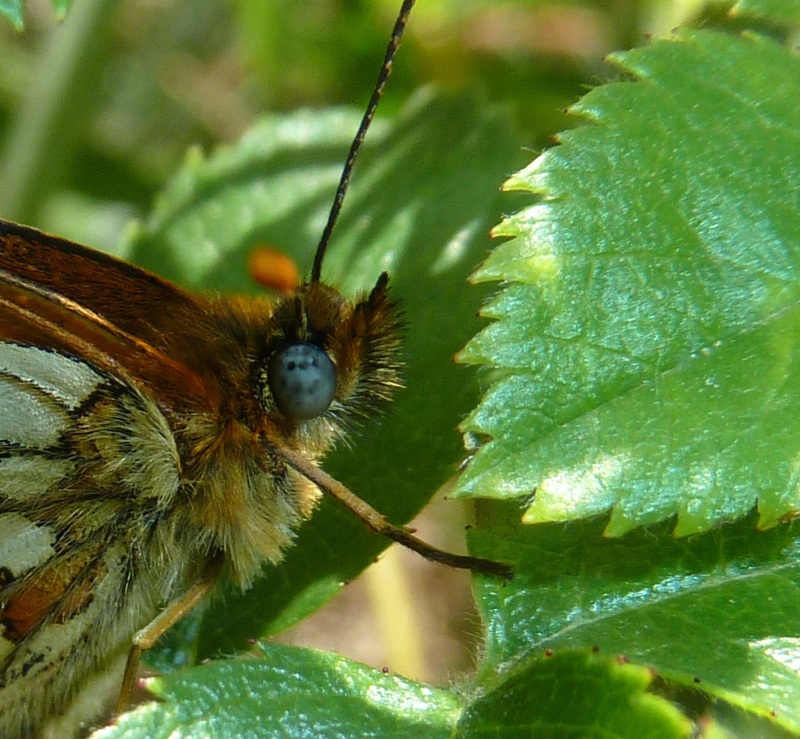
[268,343,336,421]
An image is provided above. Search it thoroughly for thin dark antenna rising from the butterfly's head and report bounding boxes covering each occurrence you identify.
[310,0,415,282]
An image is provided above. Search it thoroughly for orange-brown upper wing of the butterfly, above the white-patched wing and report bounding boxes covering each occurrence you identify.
[0,221,216,411]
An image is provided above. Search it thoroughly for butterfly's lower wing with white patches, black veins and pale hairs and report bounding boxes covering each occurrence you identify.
[0,341,200,736]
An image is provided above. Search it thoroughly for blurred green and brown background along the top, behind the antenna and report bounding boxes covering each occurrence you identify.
[0,0,725,248]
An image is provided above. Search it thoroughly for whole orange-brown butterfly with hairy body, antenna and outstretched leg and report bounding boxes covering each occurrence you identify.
[0,0,507,737]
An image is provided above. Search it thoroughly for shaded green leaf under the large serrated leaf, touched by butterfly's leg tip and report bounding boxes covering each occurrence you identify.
[470,502,800,731]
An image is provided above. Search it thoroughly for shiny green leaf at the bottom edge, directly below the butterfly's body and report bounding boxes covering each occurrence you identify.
[93,645,461,739]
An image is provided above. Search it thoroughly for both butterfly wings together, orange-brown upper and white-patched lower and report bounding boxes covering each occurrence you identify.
[0,223,216,737]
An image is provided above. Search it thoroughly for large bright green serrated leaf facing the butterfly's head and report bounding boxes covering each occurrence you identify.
[460,31,800,535]
